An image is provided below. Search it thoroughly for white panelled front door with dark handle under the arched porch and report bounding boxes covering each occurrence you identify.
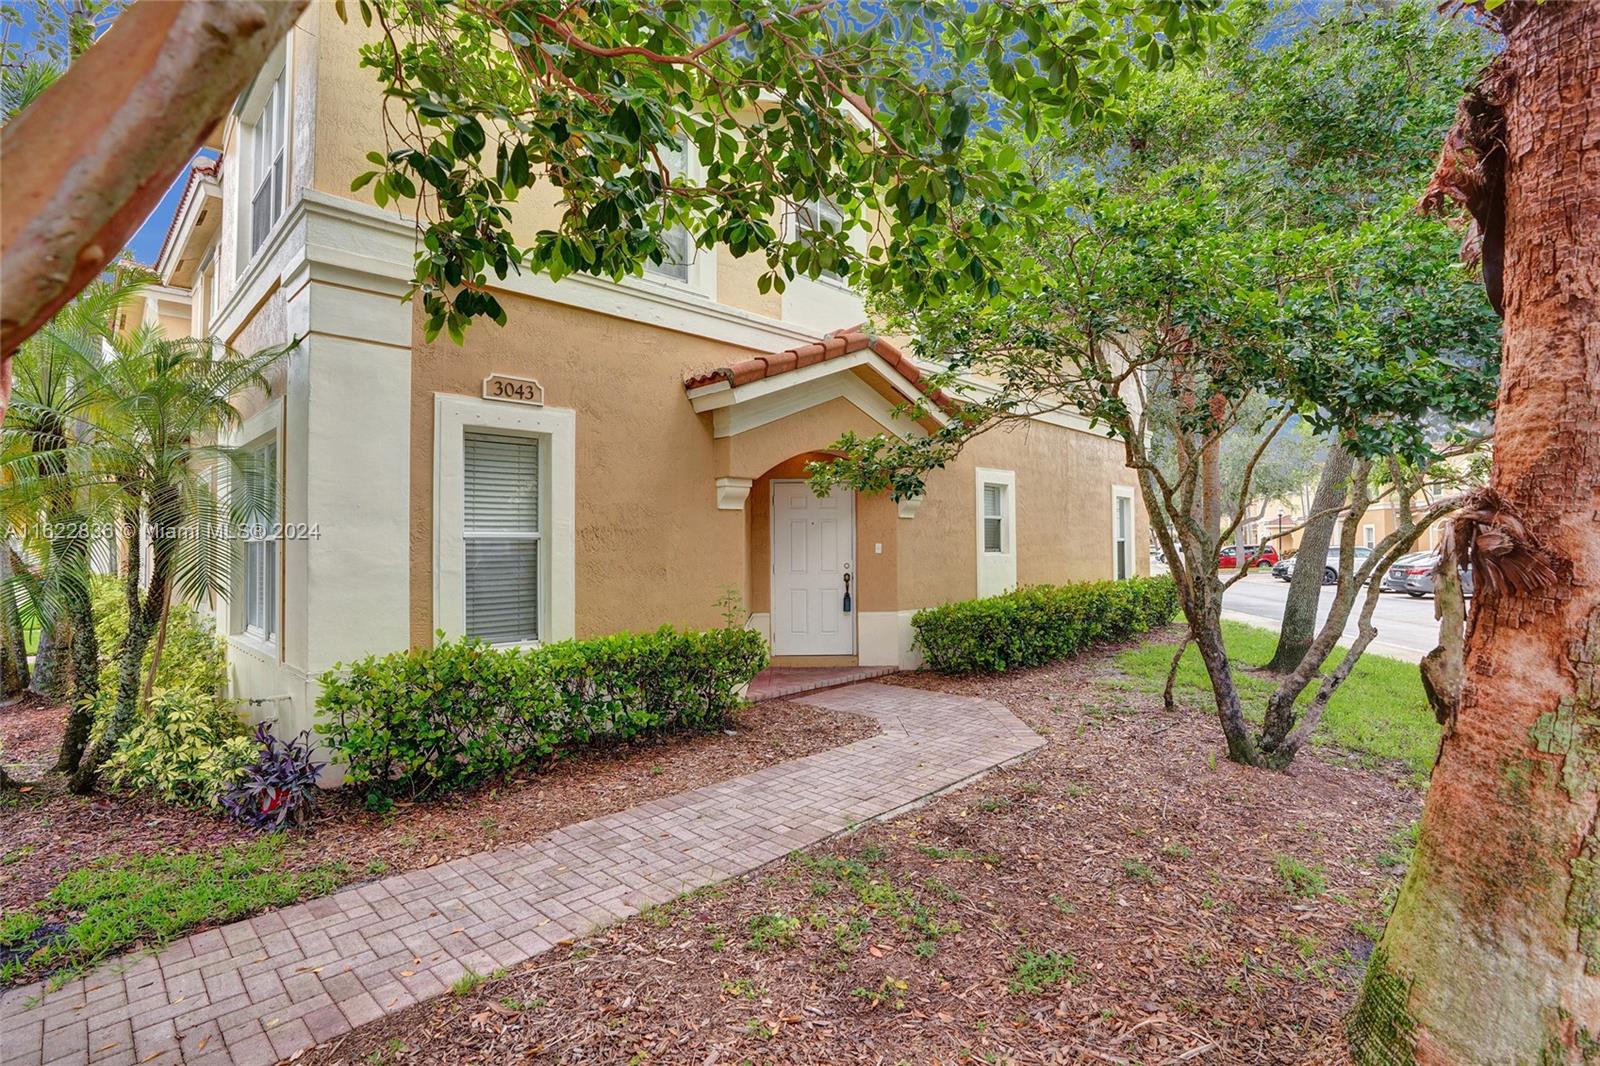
[773,482,859,655]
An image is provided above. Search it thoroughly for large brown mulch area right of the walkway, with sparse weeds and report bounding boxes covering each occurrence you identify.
[299,632,1421,1064]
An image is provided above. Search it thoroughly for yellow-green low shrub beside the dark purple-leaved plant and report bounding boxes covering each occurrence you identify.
[102,690,256,807]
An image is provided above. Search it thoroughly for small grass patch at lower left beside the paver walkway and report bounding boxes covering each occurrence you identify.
[0,834,350,984]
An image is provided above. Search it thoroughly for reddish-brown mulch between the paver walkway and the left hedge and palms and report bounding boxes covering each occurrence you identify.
[0,698,877,911]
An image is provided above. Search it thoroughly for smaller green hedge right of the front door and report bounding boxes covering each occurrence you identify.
[910,576,1178,674]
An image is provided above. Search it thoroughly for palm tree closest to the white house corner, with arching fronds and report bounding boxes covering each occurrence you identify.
[58,327,293,792]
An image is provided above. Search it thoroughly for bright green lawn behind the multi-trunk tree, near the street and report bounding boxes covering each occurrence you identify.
[1117,621,1438,776]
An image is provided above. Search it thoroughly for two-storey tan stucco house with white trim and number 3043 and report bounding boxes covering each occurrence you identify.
[158,3,1147,739]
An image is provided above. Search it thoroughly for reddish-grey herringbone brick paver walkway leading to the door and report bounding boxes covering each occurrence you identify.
[0,683,1043,1066]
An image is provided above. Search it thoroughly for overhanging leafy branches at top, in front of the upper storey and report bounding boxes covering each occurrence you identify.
[341,0,1227,338]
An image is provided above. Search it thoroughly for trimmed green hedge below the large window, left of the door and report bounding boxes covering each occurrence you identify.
[317,626,766,797]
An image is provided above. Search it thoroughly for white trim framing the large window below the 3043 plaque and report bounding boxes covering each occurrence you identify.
[434,392,578,647]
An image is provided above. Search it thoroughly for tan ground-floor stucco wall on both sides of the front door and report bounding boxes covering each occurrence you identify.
[410,281,1147,645]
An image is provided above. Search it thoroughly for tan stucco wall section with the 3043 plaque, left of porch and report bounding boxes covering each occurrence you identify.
[411,286,761,645]
